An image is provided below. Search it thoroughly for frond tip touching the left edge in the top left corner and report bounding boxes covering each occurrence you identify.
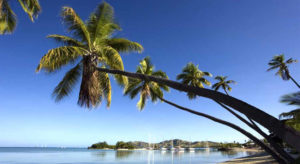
[0,0,16,35]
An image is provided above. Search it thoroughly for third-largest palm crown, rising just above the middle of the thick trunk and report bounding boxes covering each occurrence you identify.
[177,63,212,99]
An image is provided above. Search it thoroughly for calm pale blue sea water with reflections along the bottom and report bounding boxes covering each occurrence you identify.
[0,147,252,164]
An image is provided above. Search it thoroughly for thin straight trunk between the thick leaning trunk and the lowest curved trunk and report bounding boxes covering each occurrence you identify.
[216,101,295,163]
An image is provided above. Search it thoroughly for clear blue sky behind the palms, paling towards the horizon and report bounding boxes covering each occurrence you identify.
[0,0,300,146]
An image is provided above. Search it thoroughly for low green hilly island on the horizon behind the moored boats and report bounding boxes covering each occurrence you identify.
[88,139,246,150]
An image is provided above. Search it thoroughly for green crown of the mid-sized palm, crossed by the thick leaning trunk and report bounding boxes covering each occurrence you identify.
[124,57,169,110]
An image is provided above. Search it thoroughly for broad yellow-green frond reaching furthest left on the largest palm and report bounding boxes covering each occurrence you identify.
[36,46,86,72]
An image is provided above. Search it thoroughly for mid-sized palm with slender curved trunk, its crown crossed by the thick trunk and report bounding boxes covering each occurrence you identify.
[124,57,284,163]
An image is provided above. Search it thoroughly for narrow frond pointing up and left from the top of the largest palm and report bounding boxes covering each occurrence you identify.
[61,7,91,47]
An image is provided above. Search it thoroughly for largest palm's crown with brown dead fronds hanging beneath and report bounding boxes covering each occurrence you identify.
[36,2,143,108]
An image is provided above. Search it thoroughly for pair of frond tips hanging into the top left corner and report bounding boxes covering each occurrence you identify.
[0,0,41,34]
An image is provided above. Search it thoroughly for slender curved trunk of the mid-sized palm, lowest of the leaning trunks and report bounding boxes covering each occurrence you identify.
[158,96,287,164]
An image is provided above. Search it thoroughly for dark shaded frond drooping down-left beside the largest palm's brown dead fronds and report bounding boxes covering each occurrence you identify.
[52,63,82,102]
